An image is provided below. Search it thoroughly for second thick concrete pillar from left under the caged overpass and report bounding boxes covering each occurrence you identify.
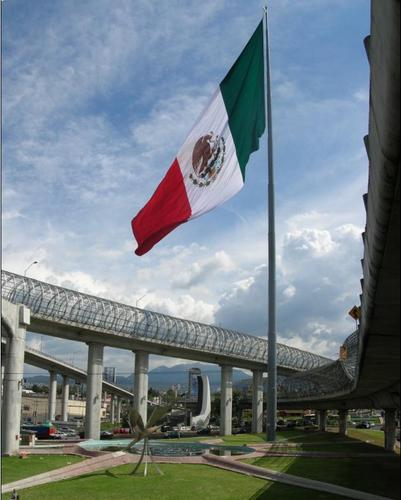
[85,342,104,439]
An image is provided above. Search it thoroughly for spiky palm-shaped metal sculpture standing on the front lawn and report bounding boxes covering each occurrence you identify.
[127,406,170,476]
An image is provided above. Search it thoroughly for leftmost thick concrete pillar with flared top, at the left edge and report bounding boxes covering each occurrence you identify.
[1,300,30,455]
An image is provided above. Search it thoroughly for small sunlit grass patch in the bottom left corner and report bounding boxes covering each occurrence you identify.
[1,455,84,484]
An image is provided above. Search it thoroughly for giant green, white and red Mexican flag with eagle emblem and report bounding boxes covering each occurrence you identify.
[131,22,265,255]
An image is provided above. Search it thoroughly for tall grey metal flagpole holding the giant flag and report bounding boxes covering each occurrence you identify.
[263,5,277,441]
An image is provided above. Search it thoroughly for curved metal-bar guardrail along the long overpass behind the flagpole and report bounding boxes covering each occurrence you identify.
[2,270,332,371]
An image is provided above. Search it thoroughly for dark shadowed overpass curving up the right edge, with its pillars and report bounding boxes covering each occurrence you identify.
[278,0,400,449]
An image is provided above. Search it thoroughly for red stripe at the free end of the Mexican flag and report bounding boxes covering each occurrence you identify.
[131,159,191,255]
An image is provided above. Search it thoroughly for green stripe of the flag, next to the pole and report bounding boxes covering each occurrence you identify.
[220,22,265,180]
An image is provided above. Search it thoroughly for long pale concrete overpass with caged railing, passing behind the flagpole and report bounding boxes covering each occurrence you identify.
[2,270,331,375]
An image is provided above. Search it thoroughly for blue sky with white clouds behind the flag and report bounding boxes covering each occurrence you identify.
[2,0,370,375]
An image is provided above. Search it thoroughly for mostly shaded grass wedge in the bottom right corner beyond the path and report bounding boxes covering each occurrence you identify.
[245,456,400,499]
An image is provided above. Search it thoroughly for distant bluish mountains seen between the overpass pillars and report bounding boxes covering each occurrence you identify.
[25,363,249,392]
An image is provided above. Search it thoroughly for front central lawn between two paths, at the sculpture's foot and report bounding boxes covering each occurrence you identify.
[14,464,343,500]
